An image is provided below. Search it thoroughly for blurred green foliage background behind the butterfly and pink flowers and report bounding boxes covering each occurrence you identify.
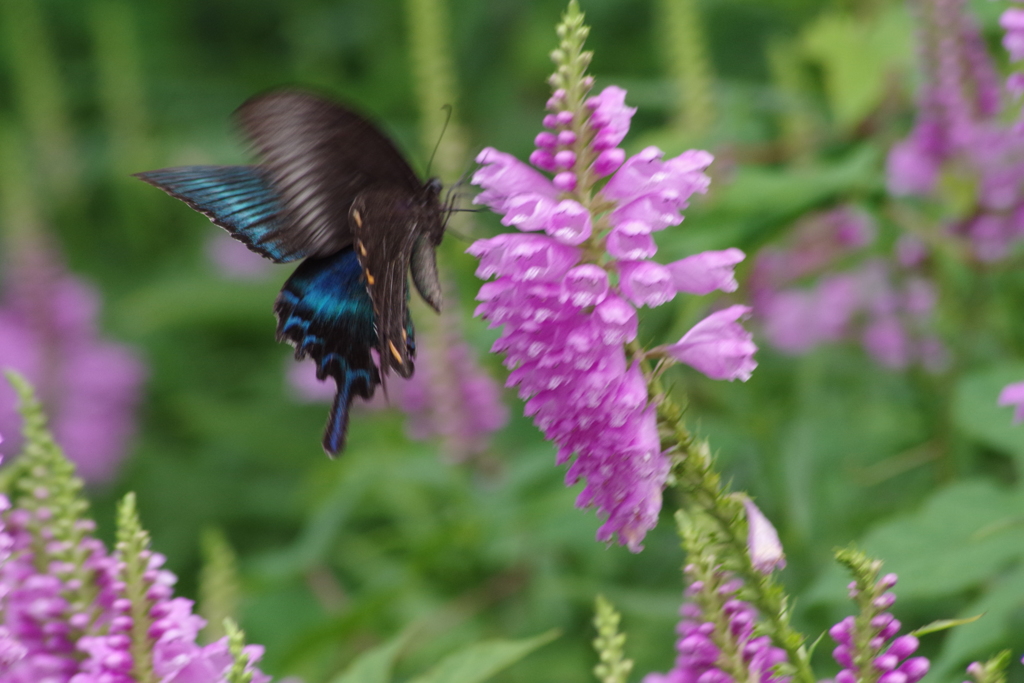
[0,0,1024,683]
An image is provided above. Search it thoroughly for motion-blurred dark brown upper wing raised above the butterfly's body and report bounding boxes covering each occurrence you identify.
[234,90,423,256]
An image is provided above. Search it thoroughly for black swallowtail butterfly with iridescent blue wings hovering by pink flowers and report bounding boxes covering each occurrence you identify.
[135,89,452,456]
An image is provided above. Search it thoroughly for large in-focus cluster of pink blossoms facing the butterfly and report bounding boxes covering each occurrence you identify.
[467,78,754,551]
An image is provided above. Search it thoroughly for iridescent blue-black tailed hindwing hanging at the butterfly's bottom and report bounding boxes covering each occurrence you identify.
[273,248,415,455]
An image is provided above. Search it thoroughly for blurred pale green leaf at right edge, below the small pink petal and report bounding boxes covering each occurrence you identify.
[953,362,1024,465]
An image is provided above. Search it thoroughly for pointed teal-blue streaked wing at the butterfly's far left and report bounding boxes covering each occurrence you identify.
[135,166,305,263]
